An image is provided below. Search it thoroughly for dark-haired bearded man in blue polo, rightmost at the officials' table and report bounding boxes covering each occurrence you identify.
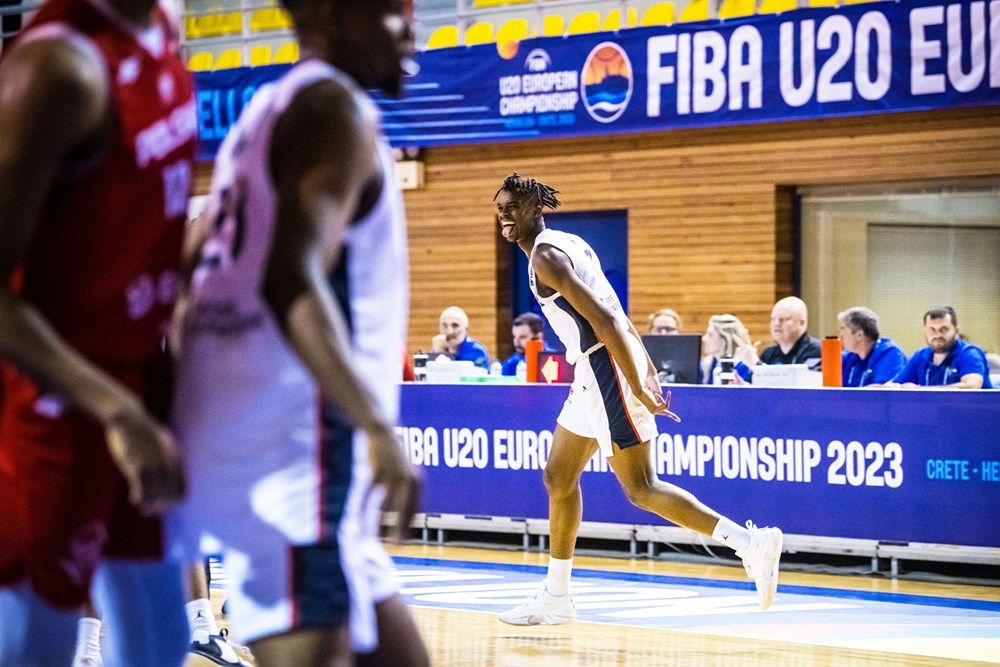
[891,306,993,389]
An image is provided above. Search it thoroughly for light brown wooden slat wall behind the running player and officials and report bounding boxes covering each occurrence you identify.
[196,107,1000,362]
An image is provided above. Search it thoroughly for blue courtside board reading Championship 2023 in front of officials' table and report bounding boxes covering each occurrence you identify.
[399,384,1000,547]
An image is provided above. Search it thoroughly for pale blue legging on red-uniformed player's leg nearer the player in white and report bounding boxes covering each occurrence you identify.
[93,559,191,667]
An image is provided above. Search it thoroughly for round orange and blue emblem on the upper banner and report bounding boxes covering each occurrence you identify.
[580,42,632,123]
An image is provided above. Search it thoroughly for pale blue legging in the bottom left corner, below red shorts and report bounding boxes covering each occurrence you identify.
[0,583,80,667]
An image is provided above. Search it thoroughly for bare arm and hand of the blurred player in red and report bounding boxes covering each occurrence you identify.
[0,39,184,511]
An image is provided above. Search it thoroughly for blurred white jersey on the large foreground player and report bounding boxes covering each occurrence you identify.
[175,61,409,465]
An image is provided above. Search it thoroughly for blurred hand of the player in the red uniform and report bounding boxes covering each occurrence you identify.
[105,410,187,514]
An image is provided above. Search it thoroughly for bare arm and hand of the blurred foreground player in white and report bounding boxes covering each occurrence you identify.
[264,81,416,527]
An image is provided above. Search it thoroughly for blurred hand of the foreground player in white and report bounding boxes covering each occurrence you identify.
[366,424,420,542]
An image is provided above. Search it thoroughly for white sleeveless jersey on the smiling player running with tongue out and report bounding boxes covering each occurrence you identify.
[528,229,629,364]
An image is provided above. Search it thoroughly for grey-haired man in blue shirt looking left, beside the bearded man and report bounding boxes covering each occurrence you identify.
[837,306,906,387]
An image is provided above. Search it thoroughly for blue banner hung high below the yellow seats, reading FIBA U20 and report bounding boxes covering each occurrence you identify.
[196,0,1000,158]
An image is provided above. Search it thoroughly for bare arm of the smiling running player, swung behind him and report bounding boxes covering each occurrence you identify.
[531,244,668,414]
